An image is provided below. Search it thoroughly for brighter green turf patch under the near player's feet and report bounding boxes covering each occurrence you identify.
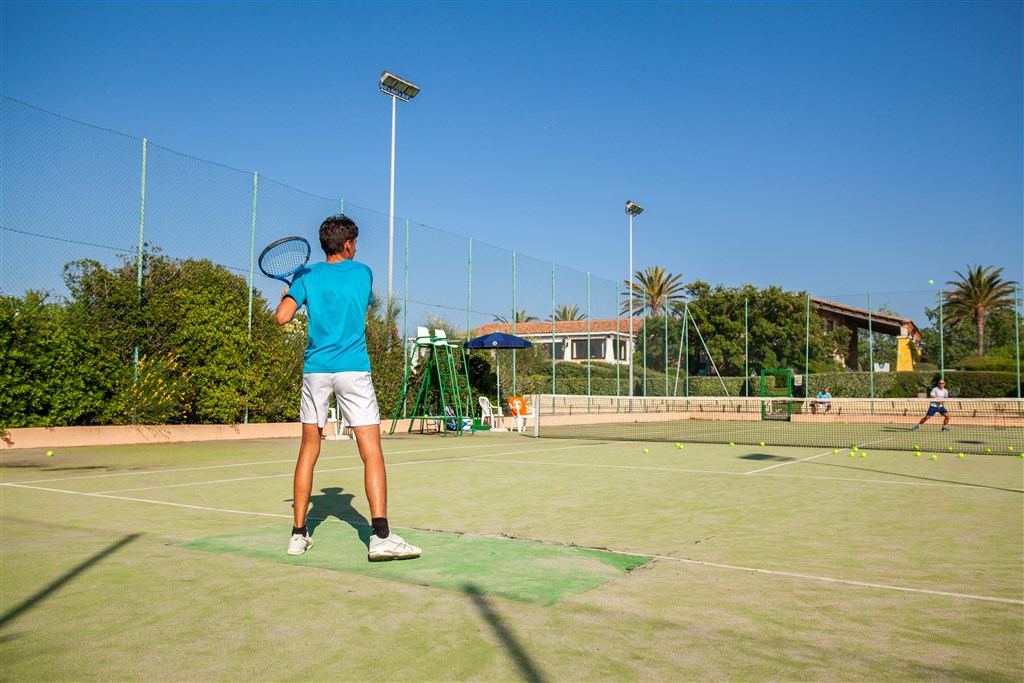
[174,524,650,605]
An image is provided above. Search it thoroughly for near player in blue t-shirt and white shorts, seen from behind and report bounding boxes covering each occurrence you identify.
[275,215,420,560]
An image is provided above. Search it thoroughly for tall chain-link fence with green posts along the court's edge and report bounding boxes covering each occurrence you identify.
[0,97,1021,426]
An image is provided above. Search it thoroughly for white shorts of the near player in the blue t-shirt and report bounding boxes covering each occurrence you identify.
[299,372,381,427]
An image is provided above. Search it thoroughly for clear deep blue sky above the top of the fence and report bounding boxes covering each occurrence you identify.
[0,0,1024,323]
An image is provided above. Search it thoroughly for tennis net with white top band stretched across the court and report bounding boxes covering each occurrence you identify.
[535,394,1024,455]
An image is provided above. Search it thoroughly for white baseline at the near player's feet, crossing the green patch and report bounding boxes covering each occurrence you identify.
[4,483,1024,605]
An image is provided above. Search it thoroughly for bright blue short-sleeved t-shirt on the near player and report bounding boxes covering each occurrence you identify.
[288,260,374,373]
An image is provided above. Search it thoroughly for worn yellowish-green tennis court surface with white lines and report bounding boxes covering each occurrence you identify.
[0,425,1024,681]
